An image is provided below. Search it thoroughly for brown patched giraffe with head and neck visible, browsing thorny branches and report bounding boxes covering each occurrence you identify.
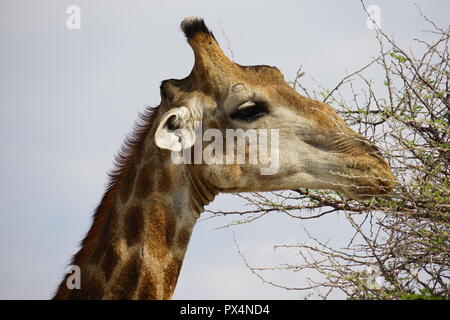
[54,17,394,299]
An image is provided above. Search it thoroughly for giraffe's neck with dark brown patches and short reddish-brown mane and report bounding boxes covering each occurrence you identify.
[55,141,217,299]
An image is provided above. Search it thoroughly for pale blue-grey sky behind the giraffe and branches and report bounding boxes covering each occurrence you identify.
[0,0,450,299]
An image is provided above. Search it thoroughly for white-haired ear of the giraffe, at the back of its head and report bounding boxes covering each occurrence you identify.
[155,106,195,151]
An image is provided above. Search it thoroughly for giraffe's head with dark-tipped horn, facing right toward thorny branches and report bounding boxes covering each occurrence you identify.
[155,18,394,199]
